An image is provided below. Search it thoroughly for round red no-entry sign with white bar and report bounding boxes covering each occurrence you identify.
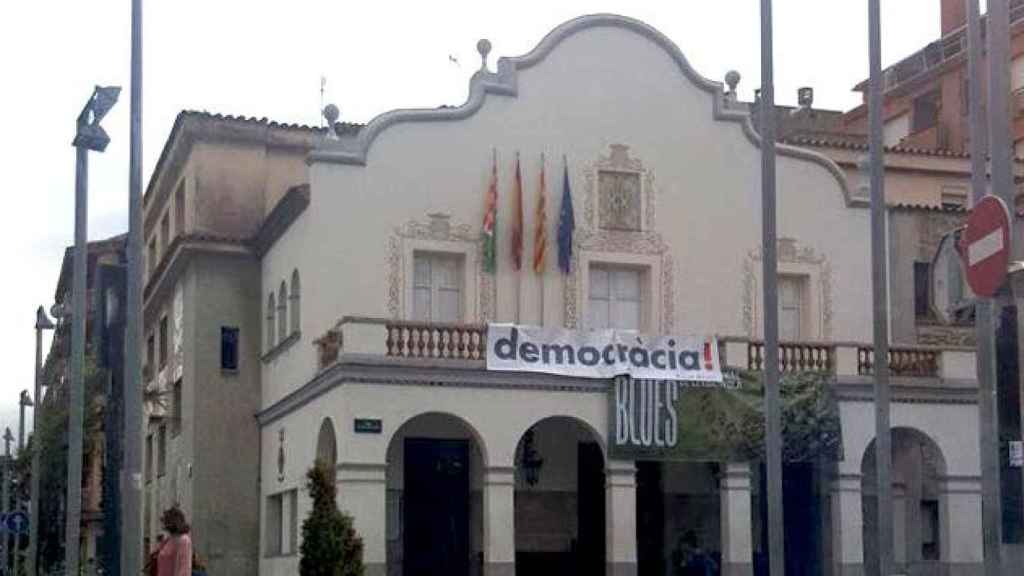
[961,196,1010,298]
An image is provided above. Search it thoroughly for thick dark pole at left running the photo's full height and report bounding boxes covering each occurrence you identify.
[121,0,142,574]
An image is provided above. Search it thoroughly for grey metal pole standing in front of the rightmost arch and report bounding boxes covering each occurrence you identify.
[867,0,893,576]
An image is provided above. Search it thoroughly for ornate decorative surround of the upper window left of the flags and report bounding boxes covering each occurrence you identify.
[387,212,495,322]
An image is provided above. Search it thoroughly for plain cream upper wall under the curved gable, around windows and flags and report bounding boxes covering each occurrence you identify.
[263,20,870,406]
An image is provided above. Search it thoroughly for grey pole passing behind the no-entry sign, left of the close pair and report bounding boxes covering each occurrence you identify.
[965,0,1002,576]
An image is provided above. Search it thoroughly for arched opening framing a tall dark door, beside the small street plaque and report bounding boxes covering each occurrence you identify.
[385,413,486,576]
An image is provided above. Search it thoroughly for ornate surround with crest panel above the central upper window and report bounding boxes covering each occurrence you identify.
[562,145,676,333]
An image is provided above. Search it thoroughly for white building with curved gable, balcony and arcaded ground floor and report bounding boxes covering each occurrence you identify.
[258,15,981,576]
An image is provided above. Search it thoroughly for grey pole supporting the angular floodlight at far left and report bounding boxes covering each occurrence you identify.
[65,140,89,574]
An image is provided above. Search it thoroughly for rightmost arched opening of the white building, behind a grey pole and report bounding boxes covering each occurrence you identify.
[860,427,949,576]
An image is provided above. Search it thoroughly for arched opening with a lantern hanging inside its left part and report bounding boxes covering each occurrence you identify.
[515,416,605,576]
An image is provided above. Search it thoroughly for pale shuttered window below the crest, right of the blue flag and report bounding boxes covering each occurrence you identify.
[588,266,643,330]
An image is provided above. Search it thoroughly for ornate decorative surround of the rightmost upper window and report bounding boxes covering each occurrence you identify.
[740,238,833,339]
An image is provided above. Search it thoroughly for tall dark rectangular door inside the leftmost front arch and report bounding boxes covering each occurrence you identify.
[403,438,469,576]
